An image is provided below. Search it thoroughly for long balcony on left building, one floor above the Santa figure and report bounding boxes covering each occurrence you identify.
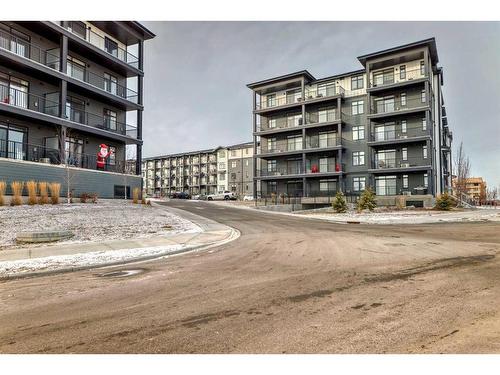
[0,84,137,138]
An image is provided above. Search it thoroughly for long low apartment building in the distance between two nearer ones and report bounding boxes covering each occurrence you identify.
[143,142,253,196]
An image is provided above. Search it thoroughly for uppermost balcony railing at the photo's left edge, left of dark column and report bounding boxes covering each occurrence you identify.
[0,30,60,70]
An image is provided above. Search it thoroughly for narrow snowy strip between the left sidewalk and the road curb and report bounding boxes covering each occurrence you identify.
[0,244,187,277]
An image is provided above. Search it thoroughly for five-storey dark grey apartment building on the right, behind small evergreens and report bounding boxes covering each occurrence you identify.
[247,38,452,203]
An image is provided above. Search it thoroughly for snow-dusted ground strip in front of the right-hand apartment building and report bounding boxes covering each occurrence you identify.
[292,209,500,224]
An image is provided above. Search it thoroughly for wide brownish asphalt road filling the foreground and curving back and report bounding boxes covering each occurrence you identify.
[0,201,500,353]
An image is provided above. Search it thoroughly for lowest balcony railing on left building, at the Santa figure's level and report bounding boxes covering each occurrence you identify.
[0,139,131,173]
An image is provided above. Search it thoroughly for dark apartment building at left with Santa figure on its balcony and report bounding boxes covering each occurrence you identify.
[0,21,154,198]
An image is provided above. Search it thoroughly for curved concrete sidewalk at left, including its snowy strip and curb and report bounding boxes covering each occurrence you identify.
[0,206,239,280]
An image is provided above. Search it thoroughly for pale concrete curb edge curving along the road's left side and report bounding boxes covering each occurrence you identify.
[0,206,241,281]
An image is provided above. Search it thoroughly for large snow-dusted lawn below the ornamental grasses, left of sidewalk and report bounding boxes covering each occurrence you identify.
[0,199,201,250]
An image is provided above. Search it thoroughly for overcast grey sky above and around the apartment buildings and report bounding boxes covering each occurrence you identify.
[143,21,500,186]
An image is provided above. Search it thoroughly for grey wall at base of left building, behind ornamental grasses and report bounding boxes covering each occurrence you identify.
[0,159,141,198]
